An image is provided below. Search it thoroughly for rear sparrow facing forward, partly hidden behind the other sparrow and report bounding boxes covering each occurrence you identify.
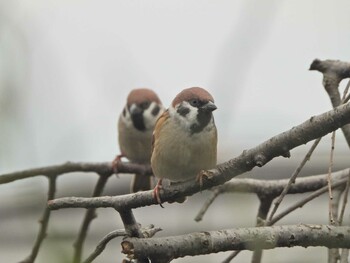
[116,88,165,192]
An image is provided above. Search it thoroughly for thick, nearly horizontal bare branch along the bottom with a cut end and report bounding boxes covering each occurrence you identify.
[122,225,350,259]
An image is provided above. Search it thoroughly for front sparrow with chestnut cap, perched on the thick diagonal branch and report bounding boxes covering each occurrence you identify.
[151,87,217,204]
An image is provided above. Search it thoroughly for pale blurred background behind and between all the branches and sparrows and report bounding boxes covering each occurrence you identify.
[0,0,350,263]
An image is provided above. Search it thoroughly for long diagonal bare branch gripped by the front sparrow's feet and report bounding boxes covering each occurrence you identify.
[48,104,350,210]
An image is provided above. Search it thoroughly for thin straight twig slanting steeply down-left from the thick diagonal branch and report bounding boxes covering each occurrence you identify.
[268,137,322,221]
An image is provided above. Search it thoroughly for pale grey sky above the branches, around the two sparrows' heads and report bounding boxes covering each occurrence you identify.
[0,0,350,172]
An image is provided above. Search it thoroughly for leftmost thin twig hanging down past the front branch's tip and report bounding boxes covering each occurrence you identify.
[20,176,56,263]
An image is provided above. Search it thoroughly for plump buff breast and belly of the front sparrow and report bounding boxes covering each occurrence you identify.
[152,119,217,181]
